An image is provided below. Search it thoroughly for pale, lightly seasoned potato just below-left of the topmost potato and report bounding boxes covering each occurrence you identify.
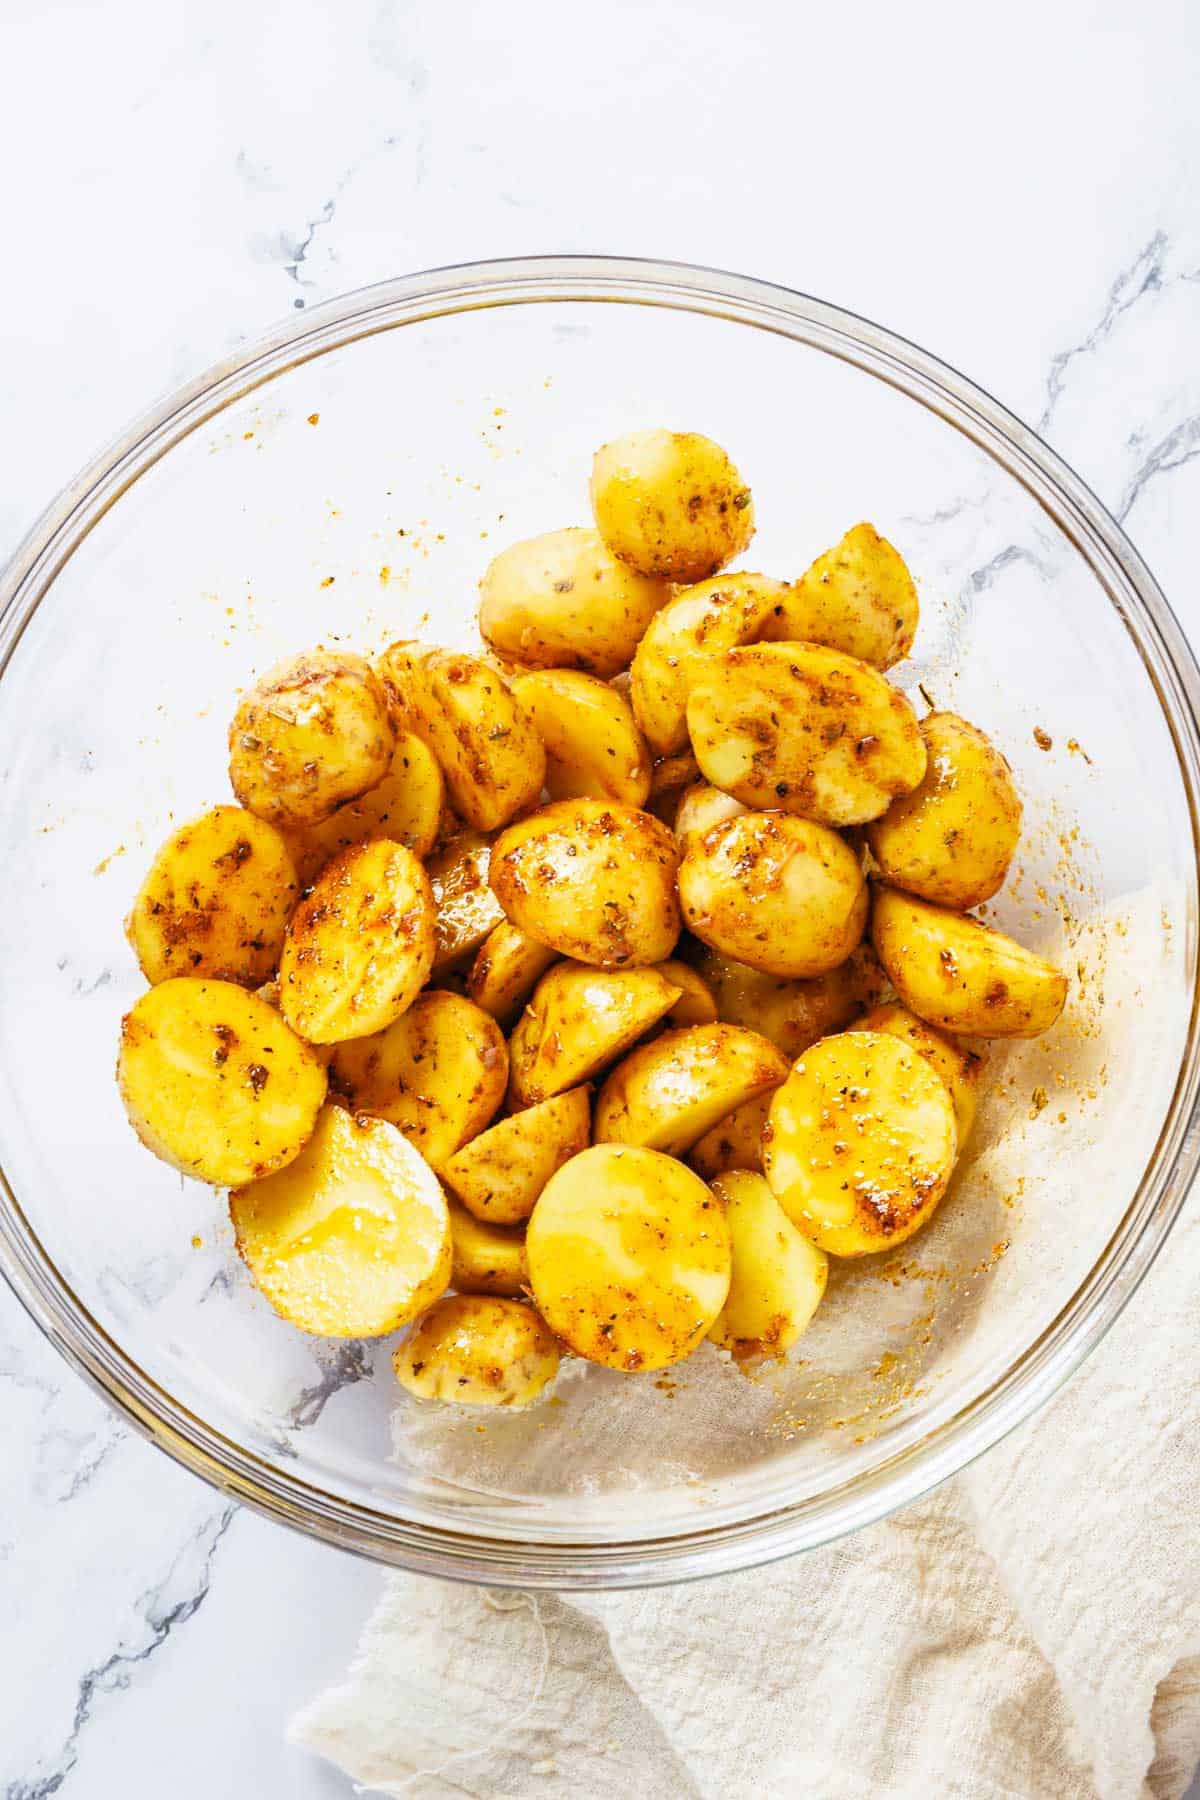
[479,526,671,679]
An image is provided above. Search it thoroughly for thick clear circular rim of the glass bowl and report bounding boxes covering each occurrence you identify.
[0,256,1200,1589]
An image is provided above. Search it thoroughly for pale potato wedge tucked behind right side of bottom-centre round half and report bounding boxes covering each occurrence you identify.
[709,1170,829,1361]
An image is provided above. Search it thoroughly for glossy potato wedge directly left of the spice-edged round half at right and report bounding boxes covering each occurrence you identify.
[594,1024,788,1156]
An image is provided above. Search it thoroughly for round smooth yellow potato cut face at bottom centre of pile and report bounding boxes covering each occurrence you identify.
[525,1143,730,1372]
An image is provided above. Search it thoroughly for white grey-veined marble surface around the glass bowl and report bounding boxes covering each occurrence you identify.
[0,0,1200,1800]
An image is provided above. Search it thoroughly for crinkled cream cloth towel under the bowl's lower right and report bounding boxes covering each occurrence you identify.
[290,1197,1200,1800]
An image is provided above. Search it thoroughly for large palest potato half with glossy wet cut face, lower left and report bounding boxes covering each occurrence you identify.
[228,1105,450,1337]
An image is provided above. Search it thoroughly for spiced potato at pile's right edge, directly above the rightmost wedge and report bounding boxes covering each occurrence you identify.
[867,713,1020,913]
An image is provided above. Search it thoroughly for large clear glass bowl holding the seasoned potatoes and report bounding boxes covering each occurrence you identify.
[0,257,1200,1588]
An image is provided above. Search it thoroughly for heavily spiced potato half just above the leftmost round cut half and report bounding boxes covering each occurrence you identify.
[126,806,300,986]
